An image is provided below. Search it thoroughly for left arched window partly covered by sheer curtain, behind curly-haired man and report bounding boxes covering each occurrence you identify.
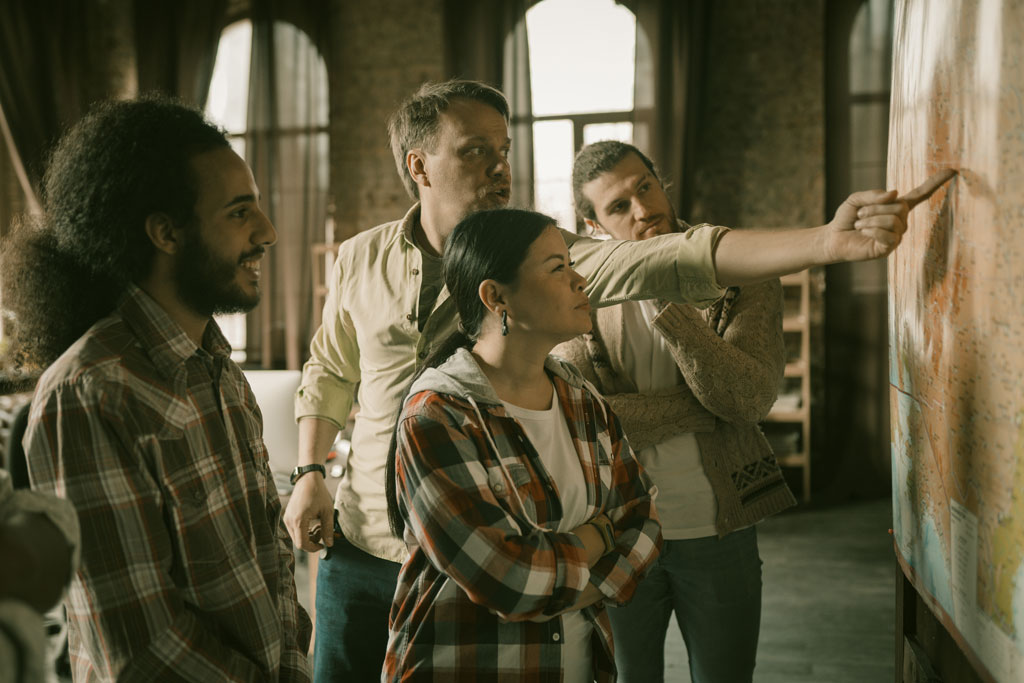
[200,19,325,369]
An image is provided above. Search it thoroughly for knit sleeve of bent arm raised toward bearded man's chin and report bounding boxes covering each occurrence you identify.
[654,280,785,423]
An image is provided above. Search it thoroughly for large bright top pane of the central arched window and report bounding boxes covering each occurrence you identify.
[526,0,636,116]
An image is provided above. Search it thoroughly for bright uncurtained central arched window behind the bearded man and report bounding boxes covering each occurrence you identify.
[526,0,636,228]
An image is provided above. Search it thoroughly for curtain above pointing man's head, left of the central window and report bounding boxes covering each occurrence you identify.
[444,0,538,207]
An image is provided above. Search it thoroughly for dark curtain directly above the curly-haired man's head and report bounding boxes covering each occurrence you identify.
[133,0,227,109]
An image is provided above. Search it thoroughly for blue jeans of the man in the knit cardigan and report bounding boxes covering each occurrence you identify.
[608,526,761,683]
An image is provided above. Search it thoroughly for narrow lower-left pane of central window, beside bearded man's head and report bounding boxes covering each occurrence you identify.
[534,120,575,230]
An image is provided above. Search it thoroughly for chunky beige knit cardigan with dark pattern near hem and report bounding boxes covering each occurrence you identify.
[553,280,796,537]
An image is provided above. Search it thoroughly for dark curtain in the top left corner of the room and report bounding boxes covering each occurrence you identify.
[0,0,101,211]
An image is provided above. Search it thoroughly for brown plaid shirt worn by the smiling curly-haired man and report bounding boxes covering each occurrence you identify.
[25,286,309,681]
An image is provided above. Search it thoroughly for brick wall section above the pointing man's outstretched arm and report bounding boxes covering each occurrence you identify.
[689,0,825,227]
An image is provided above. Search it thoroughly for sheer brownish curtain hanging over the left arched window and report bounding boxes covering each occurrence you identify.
[245,0,333,370]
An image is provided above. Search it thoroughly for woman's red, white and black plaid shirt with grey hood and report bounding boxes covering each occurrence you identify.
[383,349,662,683]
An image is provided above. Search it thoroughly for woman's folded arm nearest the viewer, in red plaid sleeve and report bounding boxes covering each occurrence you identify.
[395,409,590,621]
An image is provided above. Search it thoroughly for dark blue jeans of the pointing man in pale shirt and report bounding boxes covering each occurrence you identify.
[313,537,401,683]
